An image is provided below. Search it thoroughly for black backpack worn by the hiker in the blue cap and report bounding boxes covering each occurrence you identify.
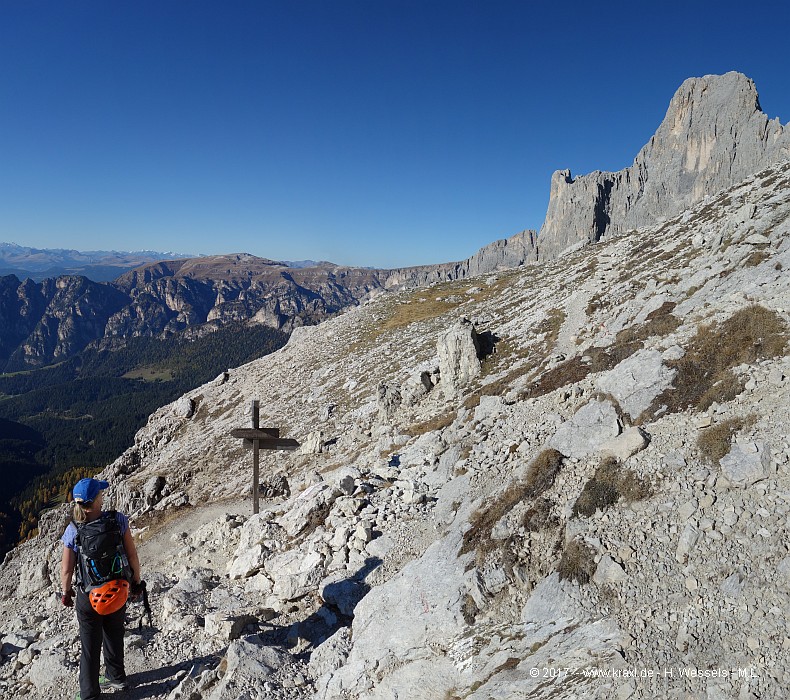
[74,510,132,593]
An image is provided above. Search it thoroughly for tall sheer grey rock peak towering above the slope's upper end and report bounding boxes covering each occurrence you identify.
[538,73,790,259]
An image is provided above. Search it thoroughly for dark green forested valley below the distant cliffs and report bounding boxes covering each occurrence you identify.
[0,324,287,554]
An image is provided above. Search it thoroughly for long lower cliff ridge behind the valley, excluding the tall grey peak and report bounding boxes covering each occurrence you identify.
[0,231,535,371]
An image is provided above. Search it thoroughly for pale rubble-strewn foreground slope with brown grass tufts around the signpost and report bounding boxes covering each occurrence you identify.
[0,156,790,700]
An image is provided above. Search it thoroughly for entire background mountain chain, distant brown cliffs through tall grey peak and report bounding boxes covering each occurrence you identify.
[0,72,790,370]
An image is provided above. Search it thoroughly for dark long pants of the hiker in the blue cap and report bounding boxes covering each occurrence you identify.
[76,591,126,700]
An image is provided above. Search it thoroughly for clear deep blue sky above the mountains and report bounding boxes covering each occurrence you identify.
[0,0,790,267]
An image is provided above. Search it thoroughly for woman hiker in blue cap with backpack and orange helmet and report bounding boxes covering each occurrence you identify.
[60,479,144,700]
